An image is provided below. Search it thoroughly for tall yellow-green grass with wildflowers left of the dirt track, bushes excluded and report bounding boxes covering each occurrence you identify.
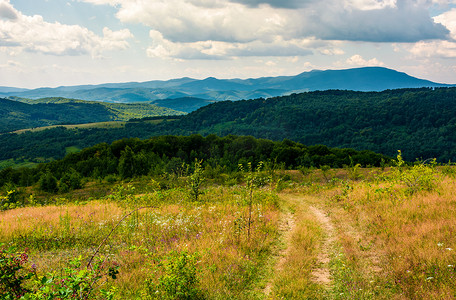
[0,187,278,299]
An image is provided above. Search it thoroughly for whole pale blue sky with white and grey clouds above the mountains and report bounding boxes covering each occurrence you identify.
[0,0,456,88]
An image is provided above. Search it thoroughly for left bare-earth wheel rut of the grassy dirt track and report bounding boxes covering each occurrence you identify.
[264,212,296,297]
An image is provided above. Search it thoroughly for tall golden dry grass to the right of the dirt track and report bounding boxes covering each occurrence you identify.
[320,170,456,299]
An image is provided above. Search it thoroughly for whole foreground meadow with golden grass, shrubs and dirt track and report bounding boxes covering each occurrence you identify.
[0,154,456,299]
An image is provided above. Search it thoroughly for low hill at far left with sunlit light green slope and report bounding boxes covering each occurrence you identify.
[0,98,183,133]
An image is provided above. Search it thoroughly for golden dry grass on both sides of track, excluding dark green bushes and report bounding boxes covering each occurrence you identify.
[4,170,456,299]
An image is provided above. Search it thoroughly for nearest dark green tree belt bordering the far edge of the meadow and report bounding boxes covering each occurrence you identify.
[0,135,390,192]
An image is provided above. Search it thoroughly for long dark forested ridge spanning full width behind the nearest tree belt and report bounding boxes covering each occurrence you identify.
[0,88,456,162]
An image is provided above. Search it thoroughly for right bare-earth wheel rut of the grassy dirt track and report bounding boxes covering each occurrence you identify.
[309,206,336,285]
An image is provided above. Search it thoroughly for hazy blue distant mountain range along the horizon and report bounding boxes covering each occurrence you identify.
[0,67,454,112]
